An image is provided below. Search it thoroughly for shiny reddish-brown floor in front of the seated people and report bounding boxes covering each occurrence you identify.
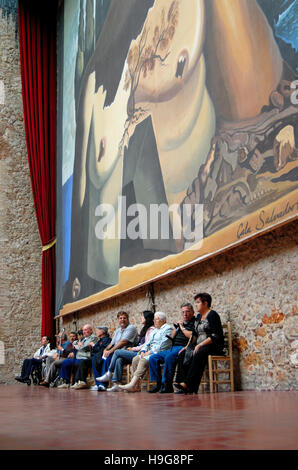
[0,384,298,452]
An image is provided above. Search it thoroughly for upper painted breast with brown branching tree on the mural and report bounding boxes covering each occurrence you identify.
[133,0,204,102]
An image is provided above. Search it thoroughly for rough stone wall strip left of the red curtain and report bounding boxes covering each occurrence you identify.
[0,0,41,383]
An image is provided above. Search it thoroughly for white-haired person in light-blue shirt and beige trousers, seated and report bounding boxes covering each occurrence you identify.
[119,312,173,392]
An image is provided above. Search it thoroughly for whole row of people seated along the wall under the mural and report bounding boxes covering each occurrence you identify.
[15,293,224,394]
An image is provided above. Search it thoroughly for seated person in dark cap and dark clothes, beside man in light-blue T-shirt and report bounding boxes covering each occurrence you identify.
[71,326,112,390]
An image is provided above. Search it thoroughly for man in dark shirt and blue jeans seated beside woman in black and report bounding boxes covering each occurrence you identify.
[148,302,195,393]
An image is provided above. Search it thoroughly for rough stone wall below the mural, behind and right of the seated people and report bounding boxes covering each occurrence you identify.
[61,221,298,390]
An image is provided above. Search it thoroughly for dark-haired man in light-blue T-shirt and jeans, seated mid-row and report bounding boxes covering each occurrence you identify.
[96,312,138,391]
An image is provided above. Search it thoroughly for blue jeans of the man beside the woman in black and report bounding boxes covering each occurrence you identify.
[149,346,183,384]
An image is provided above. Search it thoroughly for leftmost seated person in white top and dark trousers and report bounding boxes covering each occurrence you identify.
[15,336,51,385]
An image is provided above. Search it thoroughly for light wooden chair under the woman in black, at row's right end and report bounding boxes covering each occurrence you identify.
[201,321,234,393]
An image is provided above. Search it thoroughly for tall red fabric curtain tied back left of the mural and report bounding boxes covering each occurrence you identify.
[19,0,56,338]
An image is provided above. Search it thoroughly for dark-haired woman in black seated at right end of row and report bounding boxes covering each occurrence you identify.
[174,293,224,393]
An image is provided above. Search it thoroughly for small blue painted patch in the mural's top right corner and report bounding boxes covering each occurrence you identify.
[274,0,298,52]
